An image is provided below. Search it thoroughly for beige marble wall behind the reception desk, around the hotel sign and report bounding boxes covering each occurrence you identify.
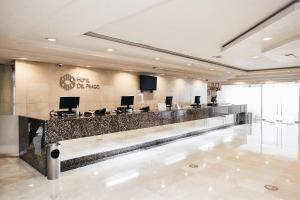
[16,61,207,117]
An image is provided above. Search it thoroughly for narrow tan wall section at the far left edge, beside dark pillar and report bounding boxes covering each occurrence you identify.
[0,65,13,115]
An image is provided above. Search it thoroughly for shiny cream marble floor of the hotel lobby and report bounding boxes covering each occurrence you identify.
[0,122,300,200]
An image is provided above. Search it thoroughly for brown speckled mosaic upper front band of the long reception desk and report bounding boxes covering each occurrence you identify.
[44,105,247,144]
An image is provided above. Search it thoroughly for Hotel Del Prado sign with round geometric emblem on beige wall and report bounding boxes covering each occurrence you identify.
[59,74,100,90]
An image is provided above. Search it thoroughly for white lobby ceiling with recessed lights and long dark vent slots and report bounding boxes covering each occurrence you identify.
[0,0,300,80]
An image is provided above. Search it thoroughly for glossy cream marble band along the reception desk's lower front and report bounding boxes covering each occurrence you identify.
[60,115,234,161]
